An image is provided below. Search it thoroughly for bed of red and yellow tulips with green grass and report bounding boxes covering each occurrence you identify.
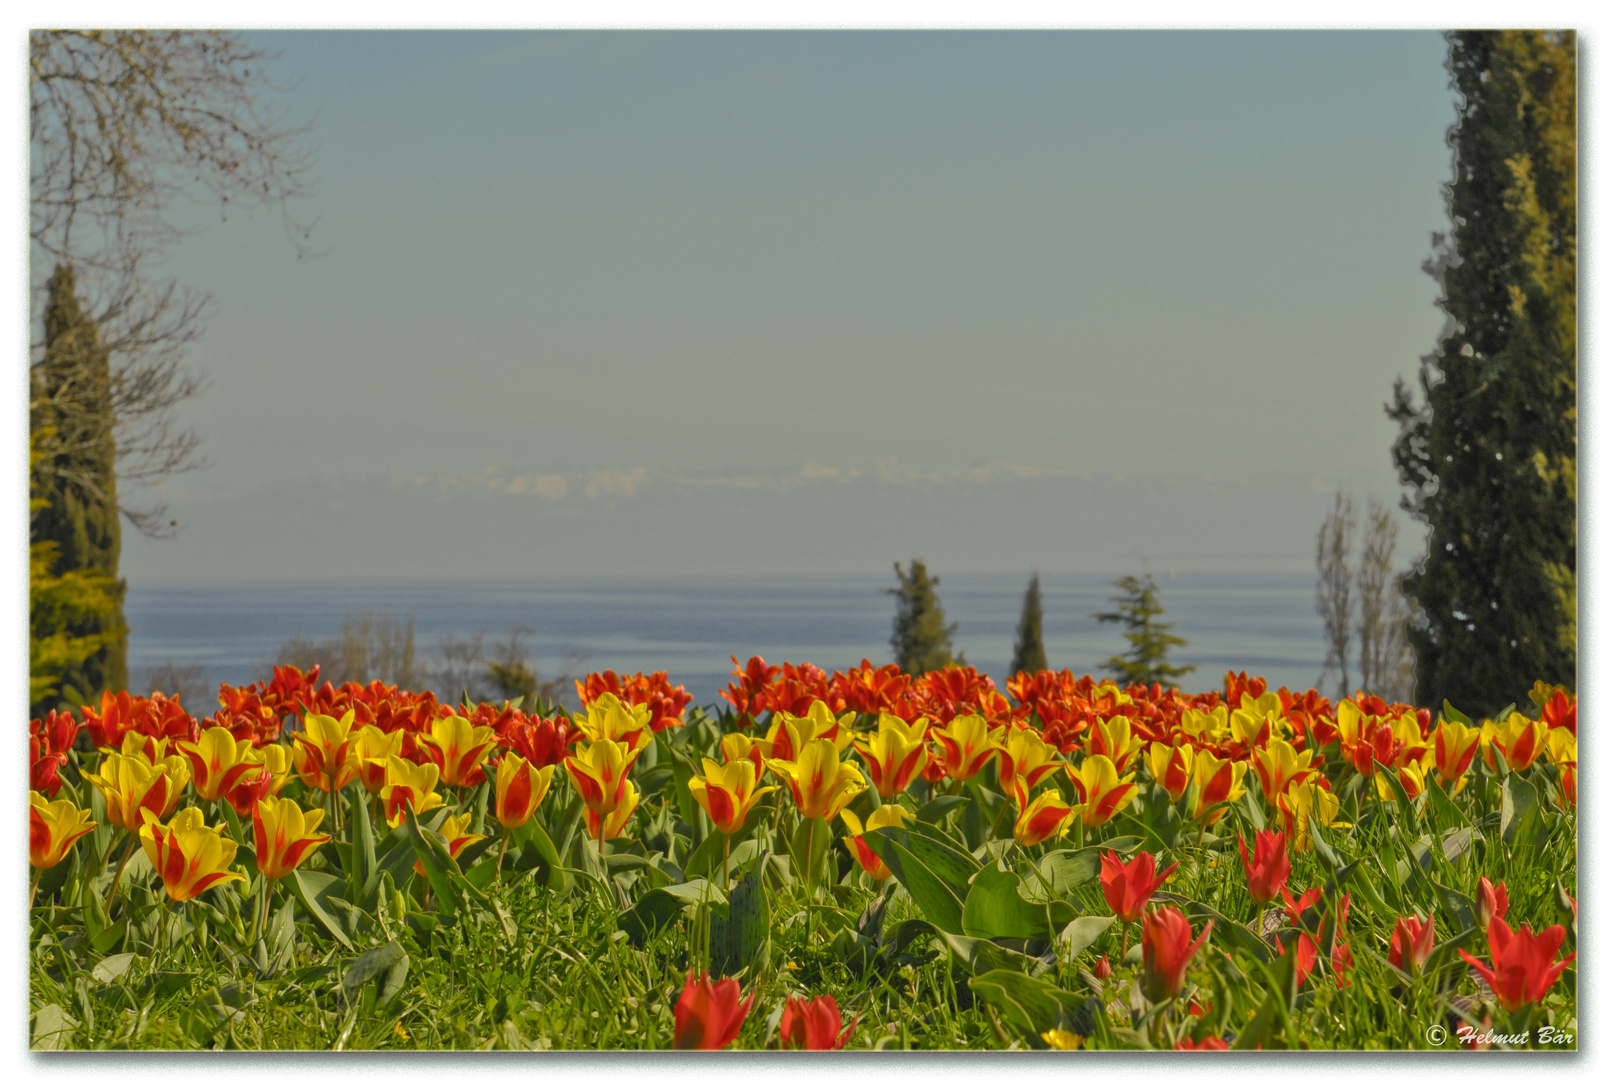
[29,657,1577,1049]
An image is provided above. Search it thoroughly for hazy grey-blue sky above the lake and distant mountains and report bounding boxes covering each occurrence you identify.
[93,32,1453,583]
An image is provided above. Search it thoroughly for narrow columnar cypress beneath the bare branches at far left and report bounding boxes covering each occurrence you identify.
[29,264,128,699]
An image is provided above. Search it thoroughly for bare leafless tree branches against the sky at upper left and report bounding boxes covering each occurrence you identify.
[29,31,312,535]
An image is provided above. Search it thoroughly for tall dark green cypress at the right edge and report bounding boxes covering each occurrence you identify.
[1388,31,1577,715]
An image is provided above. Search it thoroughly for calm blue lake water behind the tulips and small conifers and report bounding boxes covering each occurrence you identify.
[125,571,1323,707]
